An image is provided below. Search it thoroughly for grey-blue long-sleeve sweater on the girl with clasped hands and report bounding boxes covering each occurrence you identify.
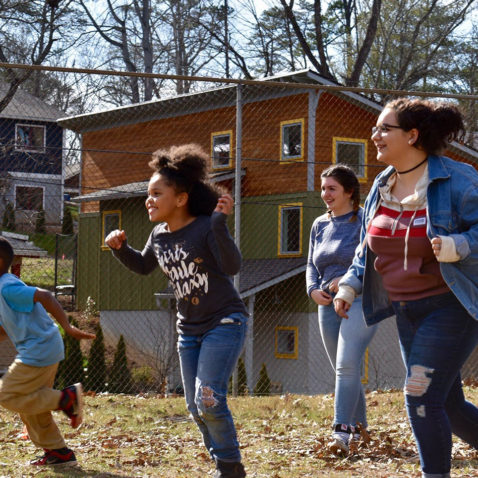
[306,208,363,296]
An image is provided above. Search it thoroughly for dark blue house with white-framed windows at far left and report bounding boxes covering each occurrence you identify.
[0,82,64,232]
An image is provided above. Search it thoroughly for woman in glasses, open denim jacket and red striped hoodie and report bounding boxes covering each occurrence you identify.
[334,99,478,478]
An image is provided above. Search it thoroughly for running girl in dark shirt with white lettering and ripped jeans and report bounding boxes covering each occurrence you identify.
[105,145,247,478]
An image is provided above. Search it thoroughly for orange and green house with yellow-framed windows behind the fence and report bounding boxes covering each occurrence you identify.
[59,70,478,393]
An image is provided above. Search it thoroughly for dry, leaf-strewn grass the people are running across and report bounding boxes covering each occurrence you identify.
[0,387,478,478]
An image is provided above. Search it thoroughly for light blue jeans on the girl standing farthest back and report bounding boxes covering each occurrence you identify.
[319,297,377,427]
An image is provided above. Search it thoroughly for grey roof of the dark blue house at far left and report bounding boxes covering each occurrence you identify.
[0,81,66,122]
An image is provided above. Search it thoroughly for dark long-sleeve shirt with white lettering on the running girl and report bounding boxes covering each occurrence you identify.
[113,212,247,335]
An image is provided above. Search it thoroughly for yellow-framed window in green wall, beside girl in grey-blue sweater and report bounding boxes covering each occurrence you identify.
[278,203,302,256]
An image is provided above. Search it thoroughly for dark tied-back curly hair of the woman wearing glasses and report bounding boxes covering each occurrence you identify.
[385,98,465,154]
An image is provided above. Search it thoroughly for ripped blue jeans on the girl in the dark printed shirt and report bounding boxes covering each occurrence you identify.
[178,314,247,462]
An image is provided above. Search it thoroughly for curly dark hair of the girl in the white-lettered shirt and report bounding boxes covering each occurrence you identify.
[149,144,222,217]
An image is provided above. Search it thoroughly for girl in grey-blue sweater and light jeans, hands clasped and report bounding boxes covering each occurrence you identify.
[306,164,376,454]
